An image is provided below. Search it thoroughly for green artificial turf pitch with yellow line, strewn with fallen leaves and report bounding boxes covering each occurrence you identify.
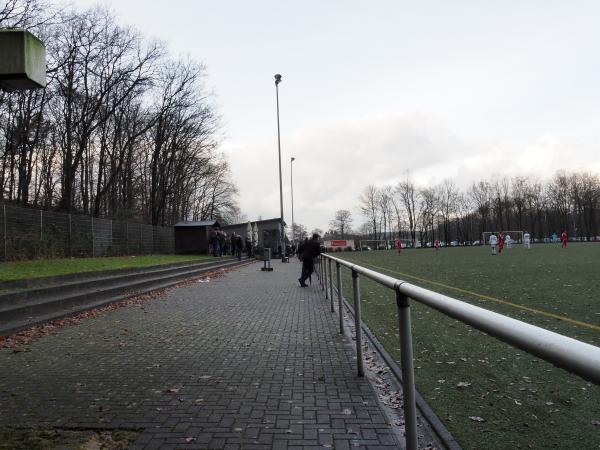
[335,243,600,449]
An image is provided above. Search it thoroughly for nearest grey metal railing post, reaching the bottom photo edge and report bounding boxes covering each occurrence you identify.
[396,290,418,450]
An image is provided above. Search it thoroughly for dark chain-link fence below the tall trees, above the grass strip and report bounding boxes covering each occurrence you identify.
[0,204,174,261]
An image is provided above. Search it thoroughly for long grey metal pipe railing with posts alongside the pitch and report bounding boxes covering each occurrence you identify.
[318,254,600,450]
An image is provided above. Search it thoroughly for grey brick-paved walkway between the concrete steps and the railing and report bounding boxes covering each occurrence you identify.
[0,262,401,449]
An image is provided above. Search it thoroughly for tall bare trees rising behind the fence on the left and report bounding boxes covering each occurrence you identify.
[0,0,238,225]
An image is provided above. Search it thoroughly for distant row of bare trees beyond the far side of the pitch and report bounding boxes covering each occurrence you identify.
[357,172,600,244]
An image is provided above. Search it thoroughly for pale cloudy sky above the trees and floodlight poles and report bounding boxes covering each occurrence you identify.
[71,0,600,231]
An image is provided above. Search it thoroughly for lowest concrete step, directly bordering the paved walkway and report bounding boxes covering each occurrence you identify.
[0,260,254,335]
